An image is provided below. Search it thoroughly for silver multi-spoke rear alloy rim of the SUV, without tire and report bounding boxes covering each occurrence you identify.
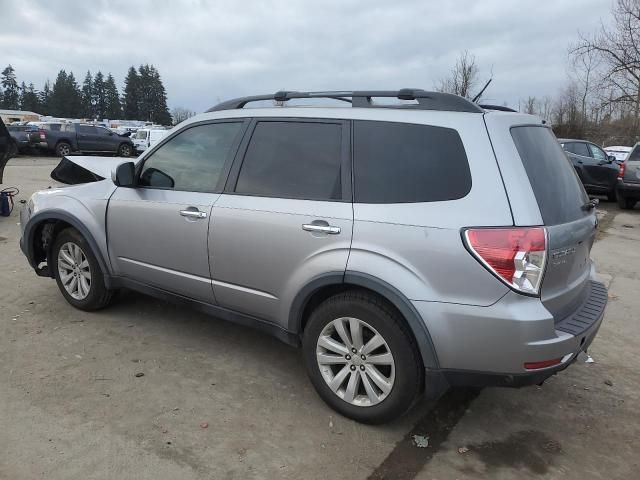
[316,317,395,407]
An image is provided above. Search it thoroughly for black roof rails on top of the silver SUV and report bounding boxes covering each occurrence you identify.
[207,88,483,113]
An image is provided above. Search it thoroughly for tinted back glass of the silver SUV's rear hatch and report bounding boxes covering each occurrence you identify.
[511,126,589,225]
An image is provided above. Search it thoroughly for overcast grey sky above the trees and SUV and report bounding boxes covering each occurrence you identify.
[0,0,611,112]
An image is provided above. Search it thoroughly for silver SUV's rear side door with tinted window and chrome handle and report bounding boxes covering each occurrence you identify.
[209,119,353,327]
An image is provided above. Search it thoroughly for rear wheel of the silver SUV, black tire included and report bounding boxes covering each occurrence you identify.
[302,291,424,424]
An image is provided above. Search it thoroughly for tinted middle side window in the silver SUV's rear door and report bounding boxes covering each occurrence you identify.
[235,121,342,200]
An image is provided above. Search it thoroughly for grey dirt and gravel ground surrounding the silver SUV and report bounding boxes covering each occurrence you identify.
[0,157,640,480]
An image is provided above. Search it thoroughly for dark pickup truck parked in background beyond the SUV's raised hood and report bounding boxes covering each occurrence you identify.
[40,123,133,157]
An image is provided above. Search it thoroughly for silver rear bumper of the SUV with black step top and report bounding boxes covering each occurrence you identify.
[414,279,607,387]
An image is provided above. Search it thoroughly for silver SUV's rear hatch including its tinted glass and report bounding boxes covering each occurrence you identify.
[510,125,597,322]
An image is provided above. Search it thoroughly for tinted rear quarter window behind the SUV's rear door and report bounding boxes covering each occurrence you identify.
[353,121,471,203]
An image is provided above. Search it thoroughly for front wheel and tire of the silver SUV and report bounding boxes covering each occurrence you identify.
[51,228,115,311]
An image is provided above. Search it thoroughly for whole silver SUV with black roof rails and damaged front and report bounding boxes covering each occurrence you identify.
[21,90,607,423]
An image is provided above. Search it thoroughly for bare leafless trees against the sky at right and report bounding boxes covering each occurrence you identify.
[436,0,640,146]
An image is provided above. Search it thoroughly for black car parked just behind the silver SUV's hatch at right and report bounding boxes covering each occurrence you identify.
[558,138,619,202]
